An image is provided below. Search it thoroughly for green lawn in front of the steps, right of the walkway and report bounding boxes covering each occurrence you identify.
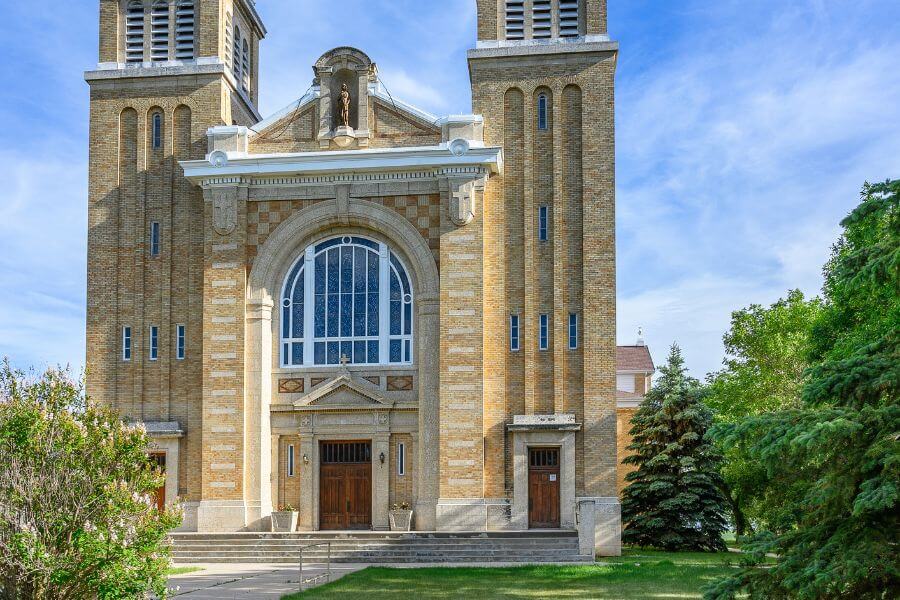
[283,549,738,600]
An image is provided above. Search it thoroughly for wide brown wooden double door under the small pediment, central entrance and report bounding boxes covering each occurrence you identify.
[319,442,372,530]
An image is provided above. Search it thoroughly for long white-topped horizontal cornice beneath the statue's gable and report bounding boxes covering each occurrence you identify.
[180,143,503,186]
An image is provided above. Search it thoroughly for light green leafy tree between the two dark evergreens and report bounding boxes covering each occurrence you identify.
[704,290,822,536]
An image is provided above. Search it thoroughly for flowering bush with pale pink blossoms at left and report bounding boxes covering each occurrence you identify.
[0,364,180,600]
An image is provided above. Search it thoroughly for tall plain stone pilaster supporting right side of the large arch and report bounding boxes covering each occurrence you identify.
[414,298,441,531]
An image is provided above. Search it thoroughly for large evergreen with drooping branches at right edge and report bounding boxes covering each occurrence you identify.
[708,181,900,599]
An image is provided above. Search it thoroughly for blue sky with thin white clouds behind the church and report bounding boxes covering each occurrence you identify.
[0,0,900,376]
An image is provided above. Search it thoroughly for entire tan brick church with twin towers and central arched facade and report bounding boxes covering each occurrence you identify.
[85,0,624,555]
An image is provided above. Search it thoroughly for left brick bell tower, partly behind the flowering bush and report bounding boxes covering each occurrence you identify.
[85,0,266,527]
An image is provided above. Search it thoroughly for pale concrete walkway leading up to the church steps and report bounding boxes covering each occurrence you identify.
[169,564,369,600]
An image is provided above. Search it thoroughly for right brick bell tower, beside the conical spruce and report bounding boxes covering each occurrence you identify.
[468,0,621,554]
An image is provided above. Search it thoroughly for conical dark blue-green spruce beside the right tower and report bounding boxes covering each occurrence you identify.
[622,345,727,551]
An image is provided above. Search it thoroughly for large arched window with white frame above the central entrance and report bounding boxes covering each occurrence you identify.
[281,236,413,367]
